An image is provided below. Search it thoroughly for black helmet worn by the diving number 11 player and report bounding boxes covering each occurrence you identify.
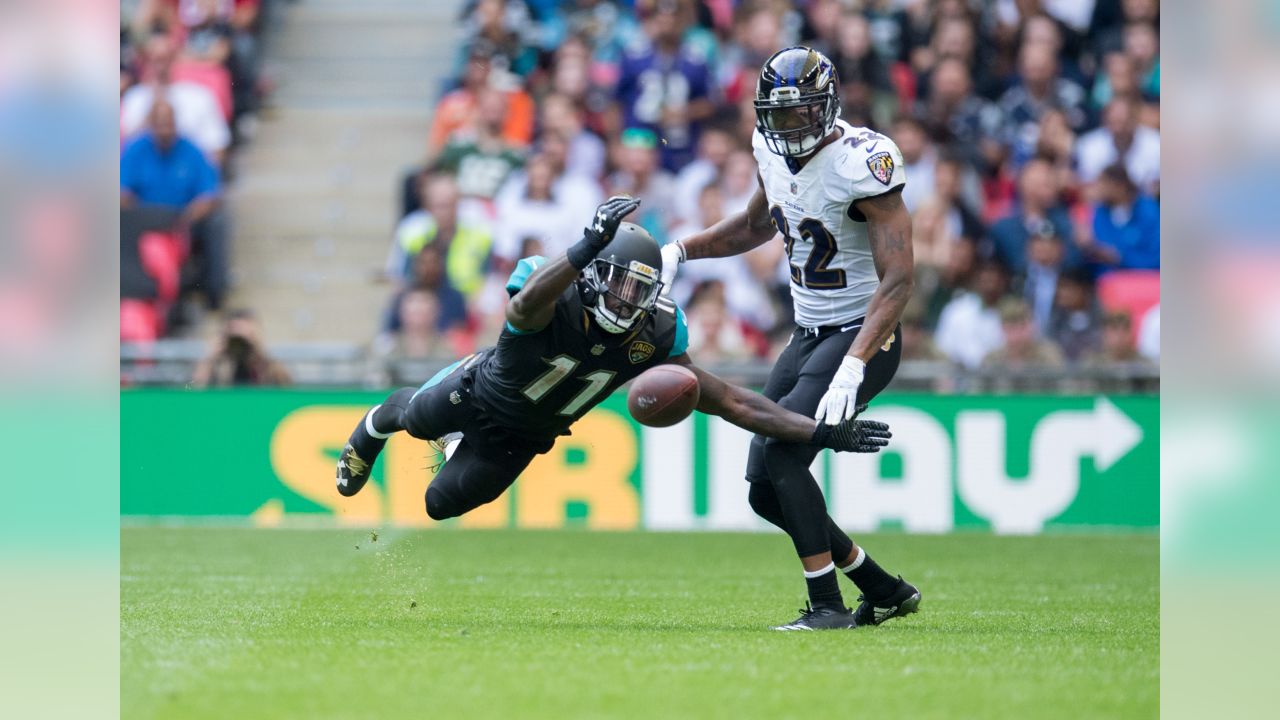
[579,223,662,333]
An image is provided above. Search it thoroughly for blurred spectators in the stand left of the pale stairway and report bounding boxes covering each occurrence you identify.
[120,0,270,341]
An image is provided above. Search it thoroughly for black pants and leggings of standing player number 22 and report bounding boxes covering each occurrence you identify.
[746,320,902,562]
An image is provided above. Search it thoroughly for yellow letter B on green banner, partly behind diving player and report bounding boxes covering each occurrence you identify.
[514,411,640,529]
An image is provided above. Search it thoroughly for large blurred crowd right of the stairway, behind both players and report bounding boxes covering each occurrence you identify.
[378,0,1160,381]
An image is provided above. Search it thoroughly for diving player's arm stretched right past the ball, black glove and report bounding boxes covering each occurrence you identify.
[671,354,892,452]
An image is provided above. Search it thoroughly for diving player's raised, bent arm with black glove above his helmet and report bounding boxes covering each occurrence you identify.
[507,195,640,332]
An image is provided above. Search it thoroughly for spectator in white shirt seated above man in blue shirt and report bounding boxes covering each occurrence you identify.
[120,33,232,168]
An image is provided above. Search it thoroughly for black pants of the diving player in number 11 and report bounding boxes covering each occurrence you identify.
[374,361,549,520]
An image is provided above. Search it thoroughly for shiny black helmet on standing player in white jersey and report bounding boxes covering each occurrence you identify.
[755,46,840,158]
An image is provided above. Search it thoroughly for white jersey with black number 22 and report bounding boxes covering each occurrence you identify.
[751,120,906,328]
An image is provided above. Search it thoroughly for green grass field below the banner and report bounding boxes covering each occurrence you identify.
[120,528,1160,720]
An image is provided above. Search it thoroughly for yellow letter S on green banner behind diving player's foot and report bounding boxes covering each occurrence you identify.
[262,406,383,525]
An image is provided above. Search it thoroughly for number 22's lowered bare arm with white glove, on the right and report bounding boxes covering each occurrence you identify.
[815,186,915,425]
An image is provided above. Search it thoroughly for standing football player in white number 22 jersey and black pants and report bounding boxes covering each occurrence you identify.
[663,47,920,630]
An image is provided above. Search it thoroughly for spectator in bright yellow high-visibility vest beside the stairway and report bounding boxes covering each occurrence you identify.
[387,174,493,297]
